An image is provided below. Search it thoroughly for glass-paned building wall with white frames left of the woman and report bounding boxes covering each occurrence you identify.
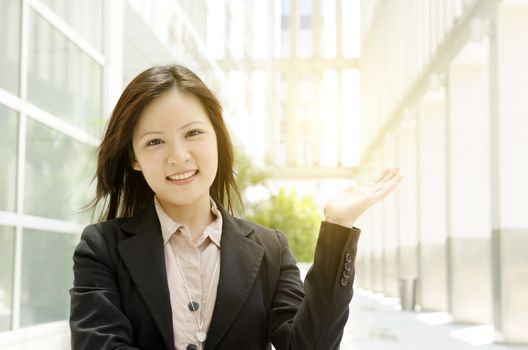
[0,0,108,348]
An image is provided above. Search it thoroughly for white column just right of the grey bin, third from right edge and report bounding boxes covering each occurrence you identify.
[418,87,447,310]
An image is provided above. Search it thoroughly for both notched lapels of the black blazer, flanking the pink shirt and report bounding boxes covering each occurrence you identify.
[118,200,264,350]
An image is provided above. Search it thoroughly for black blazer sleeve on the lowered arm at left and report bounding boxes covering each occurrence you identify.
[70,224,137,350]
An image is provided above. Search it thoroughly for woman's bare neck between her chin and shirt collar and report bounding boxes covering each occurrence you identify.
[158,196,214,240]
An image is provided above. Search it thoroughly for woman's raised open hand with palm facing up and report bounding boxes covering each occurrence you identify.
[324,168,403,227]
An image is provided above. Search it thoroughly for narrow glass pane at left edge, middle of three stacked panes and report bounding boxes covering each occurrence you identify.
[0,105,18,211]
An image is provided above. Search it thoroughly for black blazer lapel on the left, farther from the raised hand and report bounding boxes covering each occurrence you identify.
[117,201,174,349]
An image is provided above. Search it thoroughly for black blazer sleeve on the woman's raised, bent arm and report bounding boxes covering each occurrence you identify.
[268,221,360,350]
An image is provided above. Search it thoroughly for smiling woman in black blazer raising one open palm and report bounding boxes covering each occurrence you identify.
[70,65,402,350]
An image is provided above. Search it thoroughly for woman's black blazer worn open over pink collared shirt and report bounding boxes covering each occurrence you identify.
[70,201,359,350]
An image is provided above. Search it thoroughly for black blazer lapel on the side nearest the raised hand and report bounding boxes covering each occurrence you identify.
[205,203,264,350]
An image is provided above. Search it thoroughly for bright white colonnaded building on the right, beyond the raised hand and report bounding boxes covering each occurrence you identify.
[357,0,528,343]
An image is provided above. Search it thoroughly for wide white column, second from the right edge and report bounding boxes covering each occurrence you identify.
[448,40,492,323]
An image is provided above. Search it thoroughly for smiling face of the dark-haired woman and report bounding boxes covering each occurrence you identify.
[132,89,218,214]
